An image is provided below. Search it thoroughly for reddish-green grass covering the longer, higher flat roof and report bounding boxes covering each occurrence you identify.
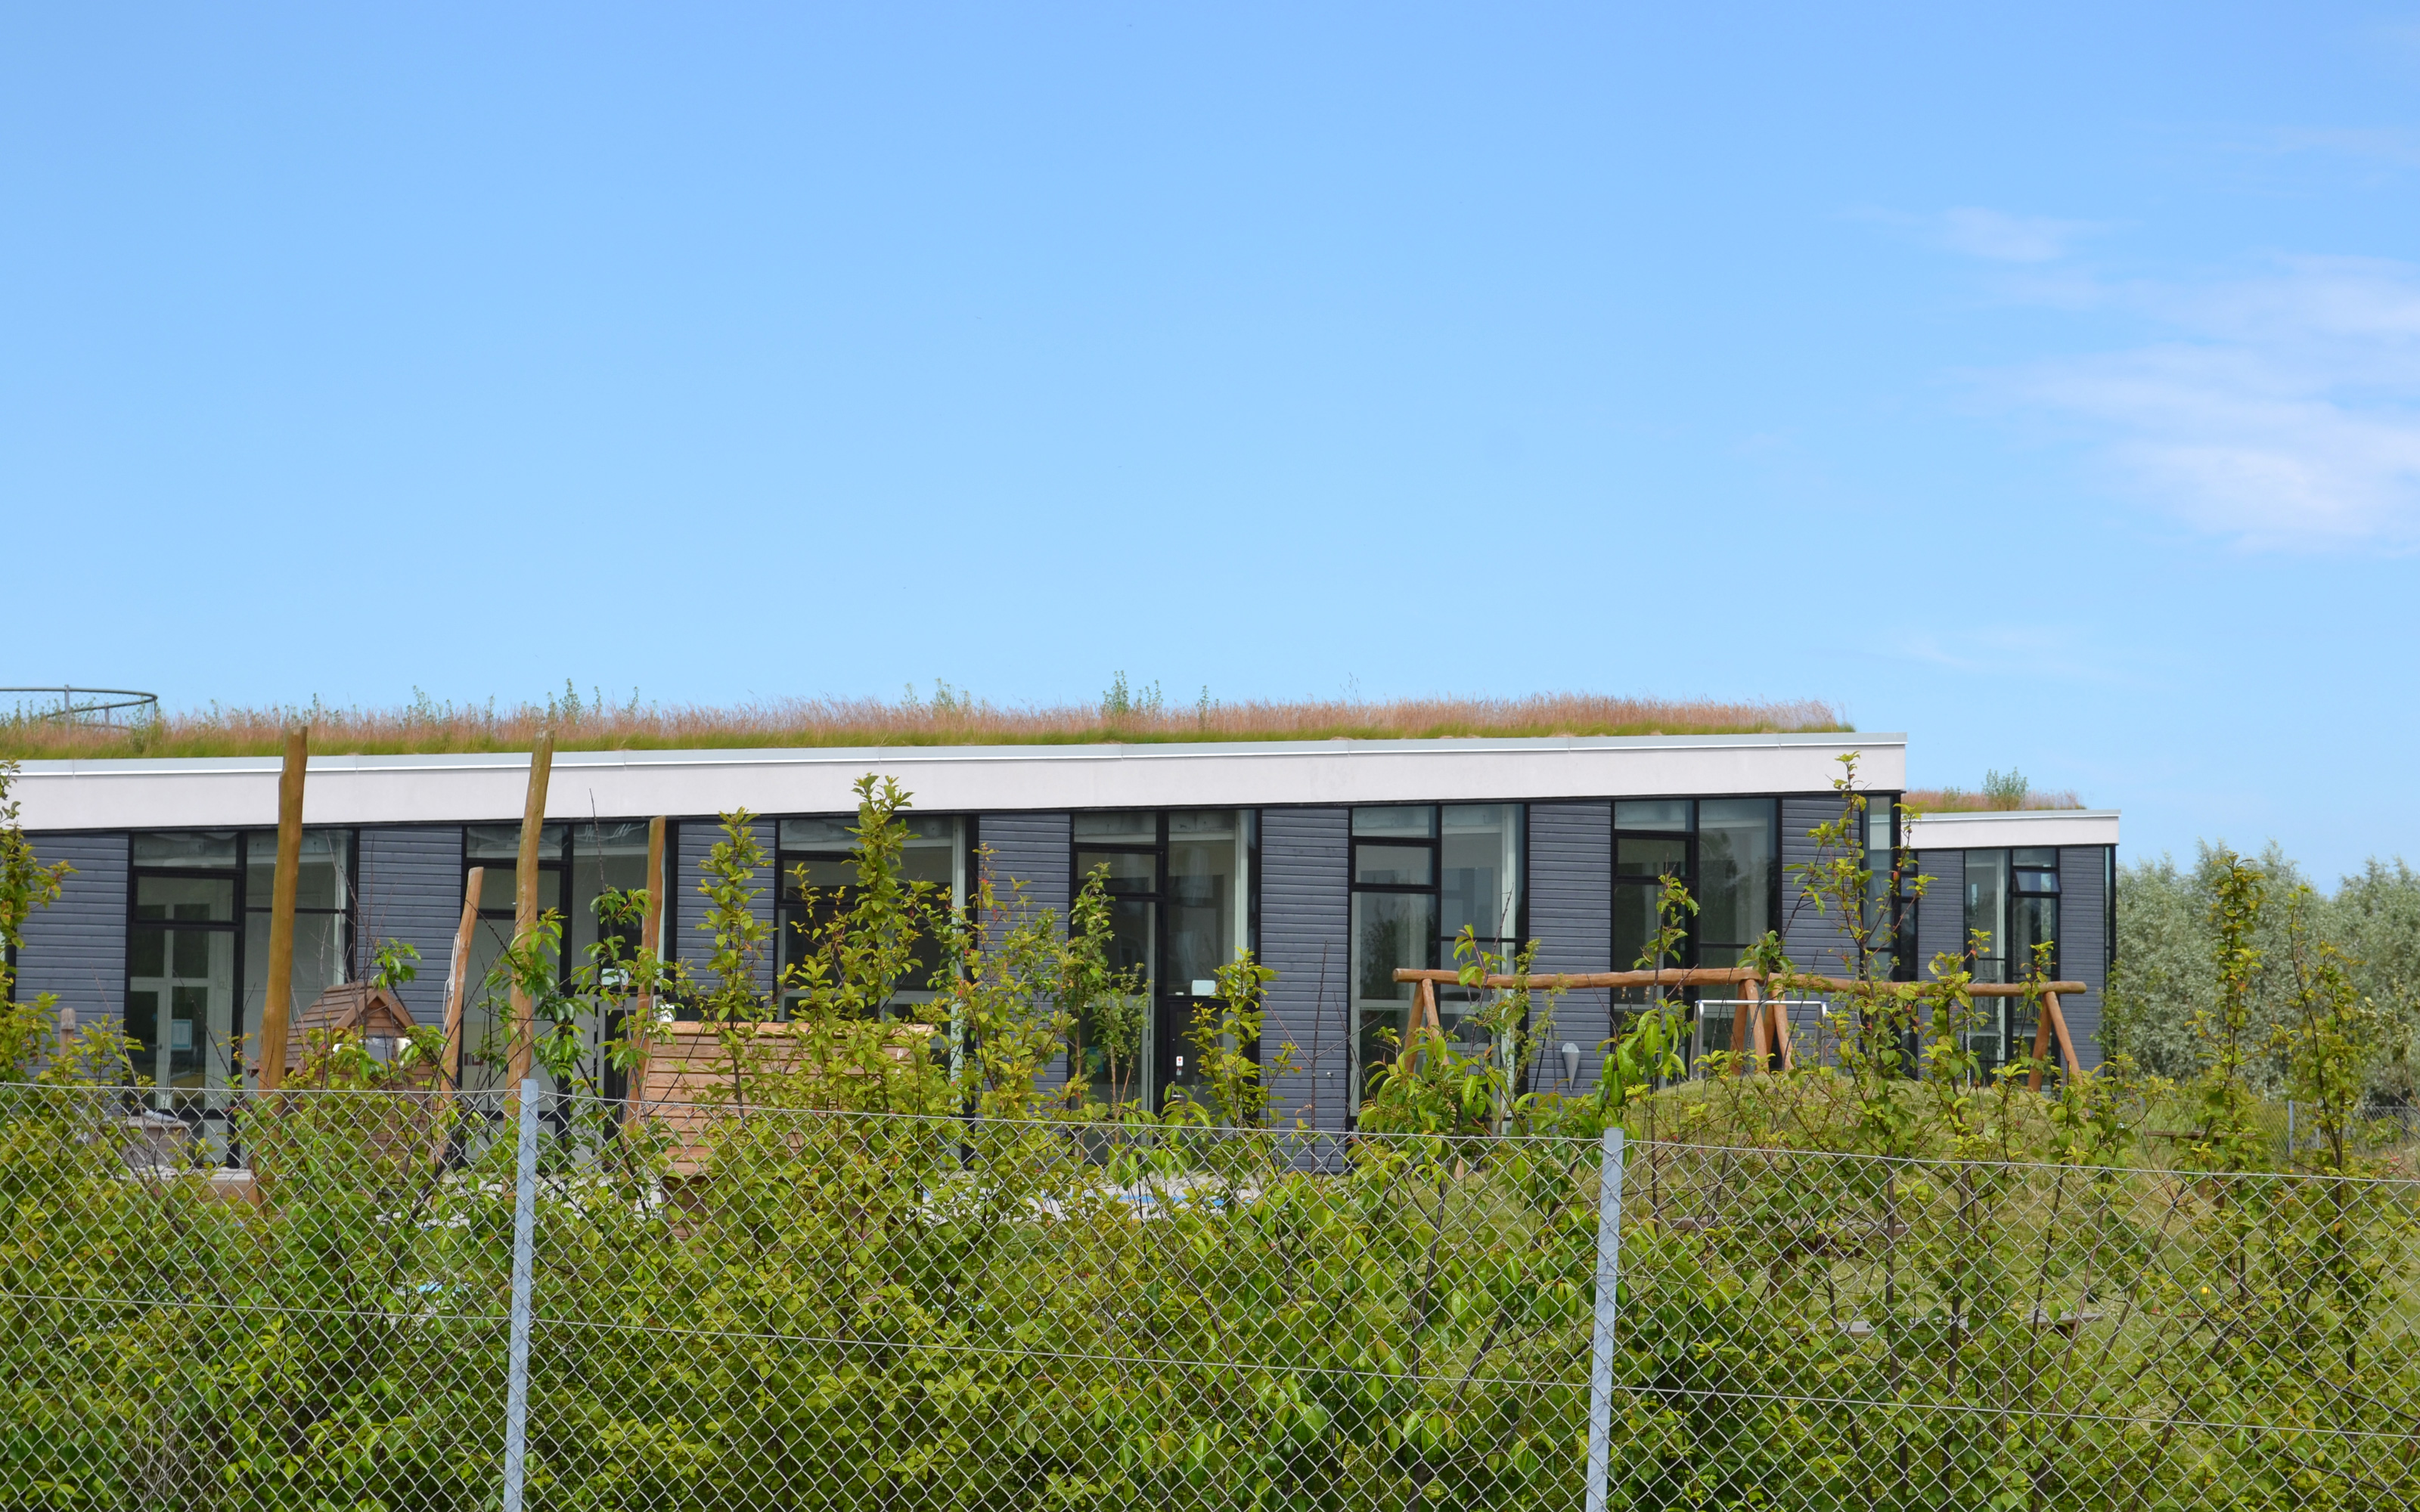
[0,675,1854,760]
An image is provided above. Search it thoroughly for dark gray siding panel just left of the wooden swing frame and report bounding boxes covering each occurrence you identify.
[1261,808,1353,1129]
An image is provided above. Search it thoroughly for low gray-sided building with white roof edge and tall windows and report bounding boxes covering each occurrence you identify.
[17,733,2118,1127]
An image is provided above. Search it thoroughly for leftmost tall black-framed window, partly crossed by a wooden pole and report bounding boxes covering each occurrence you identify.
[126,830,353,1115]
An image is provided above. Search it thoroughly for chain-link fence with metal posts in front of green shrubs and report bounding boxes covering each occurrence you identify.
[0,1089,2420,1512]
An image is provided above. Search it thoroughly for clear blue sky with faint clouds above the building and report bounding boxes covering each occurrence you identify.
[0,2,2420,875]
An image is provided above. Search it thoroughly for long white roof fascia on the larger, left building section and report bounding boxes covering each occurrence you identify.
[17,733,1897,844]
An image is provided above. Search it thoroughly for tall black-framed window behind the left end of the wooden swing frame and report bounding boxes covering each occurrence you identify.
[1351,803,1527,1096]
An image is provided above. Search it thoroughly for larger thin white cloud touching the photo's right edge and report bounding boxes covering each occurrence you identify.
[2001,259,2420,549]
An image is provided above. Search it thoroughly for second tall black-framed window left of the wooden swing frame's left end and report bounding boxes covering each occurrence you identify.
[1075,808,1258,1108]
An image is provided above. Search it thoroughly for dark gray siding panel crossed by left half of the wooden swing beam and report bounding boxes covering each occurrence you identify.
[1529,803,1629,1091]
